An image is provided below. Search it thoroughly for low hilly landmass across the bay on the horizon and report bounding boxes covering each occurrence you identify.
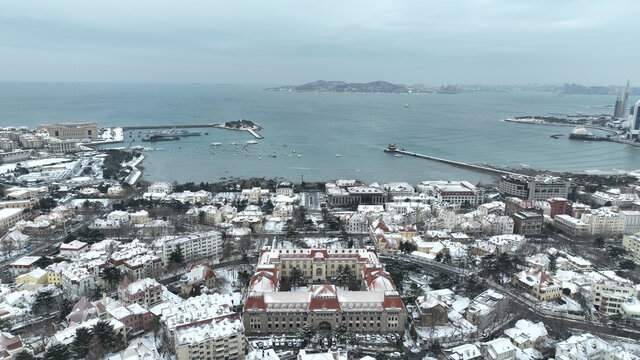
[265,80,422,93]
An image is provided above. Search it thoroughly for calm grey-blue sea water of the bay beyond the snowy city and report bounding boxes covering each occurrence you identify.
[0,83,640,183]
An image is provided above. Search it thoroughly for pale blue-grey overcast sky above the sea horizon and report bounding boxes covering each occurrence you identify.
[0,0,640,85]
